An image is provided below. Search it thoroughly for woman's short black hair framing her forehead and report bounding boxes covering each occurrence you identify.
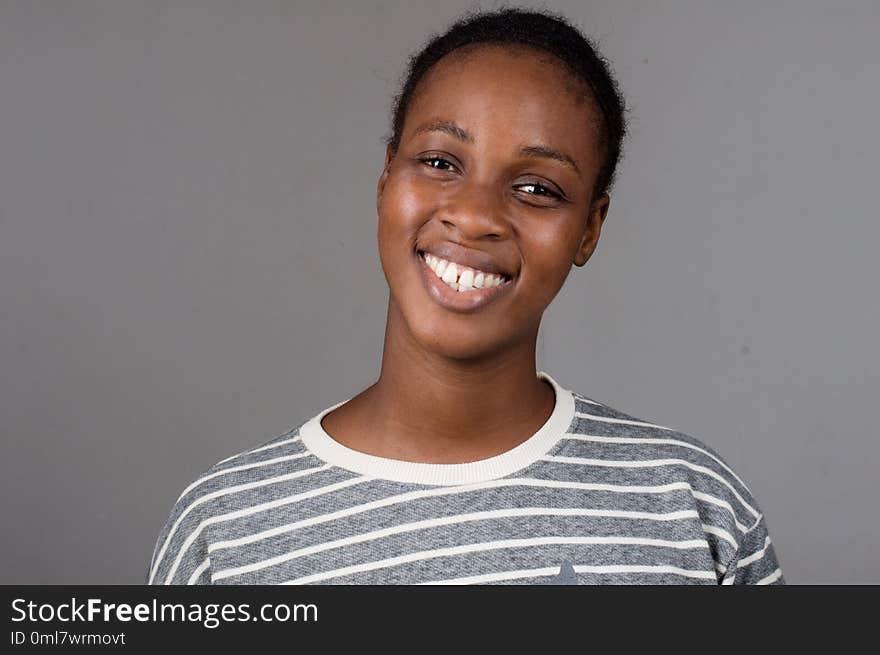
[383,7,627,197]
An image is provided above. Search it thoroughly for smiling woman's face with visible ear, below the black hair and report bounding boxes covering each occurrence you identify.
[378,45,608,359]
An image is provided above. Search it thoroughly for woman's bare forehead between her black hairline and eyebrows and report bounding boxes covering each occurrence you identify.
[403,44,599,163]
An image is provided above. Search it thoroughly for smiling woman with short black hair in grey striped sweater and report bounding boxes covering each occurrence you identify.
[148,9,783,584]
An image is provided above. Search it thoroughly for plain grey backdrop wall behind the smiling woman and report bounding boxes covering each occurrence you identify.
[0,0,880,583]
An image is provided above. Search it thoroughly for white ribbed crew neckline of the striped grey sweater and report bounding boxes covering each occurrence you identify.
[300,371,574,485]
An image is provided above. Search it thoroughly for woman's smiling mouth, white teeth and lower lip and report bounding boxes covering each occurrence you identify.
[418,250,512,313]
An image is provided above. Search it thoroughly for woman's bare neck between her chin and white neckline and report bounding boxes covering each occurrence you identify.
[354,300,555,463]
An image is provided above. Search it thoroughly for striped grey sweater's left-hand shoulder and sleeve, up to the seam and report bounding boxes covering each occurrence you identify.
[147,425,327,584]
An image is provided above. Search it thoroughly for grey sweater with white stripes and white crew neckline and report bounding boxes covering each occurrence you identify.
[147,371,784,585]
